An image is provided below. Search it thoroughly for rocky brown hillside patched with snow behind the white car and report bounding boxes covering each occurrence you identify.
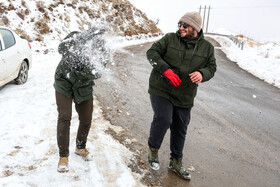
[0,0,161,42]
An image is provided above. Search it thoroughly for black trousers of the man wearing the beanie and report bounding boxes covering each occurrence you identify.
[148,95,191,159]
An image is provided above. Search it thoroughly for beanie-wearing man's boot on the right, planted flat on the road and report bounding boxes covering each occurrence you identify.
[169,157,191,180]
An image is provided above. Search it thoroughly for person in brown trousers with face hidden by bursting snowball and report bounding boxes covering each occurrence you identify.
[54,27,109,172]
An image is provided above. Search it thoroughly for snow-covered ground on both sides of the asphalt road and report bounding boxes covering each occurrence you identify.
[0,30,280,186]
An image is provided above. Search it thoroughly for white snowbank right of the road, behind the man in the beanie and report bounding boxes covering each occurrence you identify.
[209,29,280,88]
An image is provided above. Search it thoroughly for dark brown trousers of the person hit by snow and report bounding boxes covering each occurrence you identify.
[55,92,93,157]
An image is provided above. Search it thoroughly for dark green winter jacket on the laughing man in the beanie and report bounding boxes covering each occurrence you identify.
[147,30,216,108]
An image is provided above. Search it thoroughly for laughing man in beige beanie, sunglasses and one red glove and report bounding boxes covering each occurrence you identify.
[147,12,216,179]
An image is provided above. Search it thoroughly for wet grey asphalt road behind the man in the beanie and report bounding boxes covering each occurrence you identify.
[94,39,280,187]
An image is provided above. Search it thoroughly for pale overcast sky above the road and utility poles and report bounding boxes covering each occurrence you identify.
[129,0,280,42]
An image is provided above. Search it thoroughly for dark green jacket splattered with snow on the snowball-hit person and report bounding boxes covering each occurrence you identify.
[54,30,107,103]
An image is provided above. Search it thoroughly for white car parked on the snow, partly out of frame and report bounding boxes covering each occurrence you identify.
[0,26,32,87]
